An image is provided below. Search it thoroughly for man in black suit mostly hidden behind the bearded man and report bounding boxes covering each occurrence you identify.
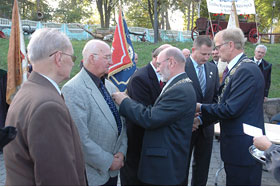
[120,44,171,186]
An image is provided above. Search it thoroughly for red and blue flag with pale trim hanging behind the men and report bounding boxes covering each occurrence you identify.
[108,9,136,91]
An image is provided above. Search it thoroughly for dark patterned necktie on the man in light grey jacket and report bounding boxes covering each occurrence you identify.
[100,81,122,135]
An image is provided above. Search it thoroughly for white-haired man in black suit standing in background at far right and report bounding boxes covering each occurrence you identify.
[251,45,272,101]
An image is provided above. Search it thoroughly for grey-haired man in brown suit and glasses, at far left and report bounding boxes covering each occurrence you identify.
[4,29,86,186]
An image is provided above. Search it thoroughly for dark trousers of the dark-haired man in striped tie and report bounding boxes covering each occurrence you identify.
[185,128,213,186]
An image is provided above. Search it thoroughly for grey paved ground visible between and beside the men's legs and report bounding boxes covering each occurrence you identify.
[0,140,279,186]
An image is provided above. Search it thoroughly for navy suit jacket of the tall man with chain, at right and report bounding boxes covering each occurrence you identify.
[201,55,264,165]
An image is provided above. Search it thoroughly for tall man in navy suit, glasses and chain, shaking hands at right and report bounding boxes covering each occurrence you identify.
[196,28,264,186]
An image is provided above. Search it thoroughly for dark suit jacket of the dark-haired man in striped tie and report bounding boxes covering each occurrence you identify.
[186,57,220,137]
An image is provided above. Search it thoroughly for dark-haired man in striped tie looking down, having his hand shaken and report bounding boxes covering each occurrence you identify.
[186,36,219,186]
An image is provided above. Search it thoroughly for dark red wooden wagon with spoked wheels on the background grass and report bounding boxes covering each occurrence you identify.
[191,17,259,43]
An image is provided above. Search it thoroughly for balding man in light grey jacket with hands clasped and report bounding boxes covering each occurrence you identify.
[62,40,127,186]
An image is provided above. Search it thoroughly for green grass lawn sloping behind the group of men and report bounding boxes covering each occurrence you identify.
[0,39,280,98]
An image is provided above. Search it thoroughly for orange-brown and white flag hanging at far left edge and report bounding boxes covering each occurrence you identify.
[6,0,27,104]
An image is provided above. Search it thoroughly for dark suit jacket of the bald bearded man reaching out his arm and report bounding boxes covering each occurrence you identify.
[120,73,196,185]
